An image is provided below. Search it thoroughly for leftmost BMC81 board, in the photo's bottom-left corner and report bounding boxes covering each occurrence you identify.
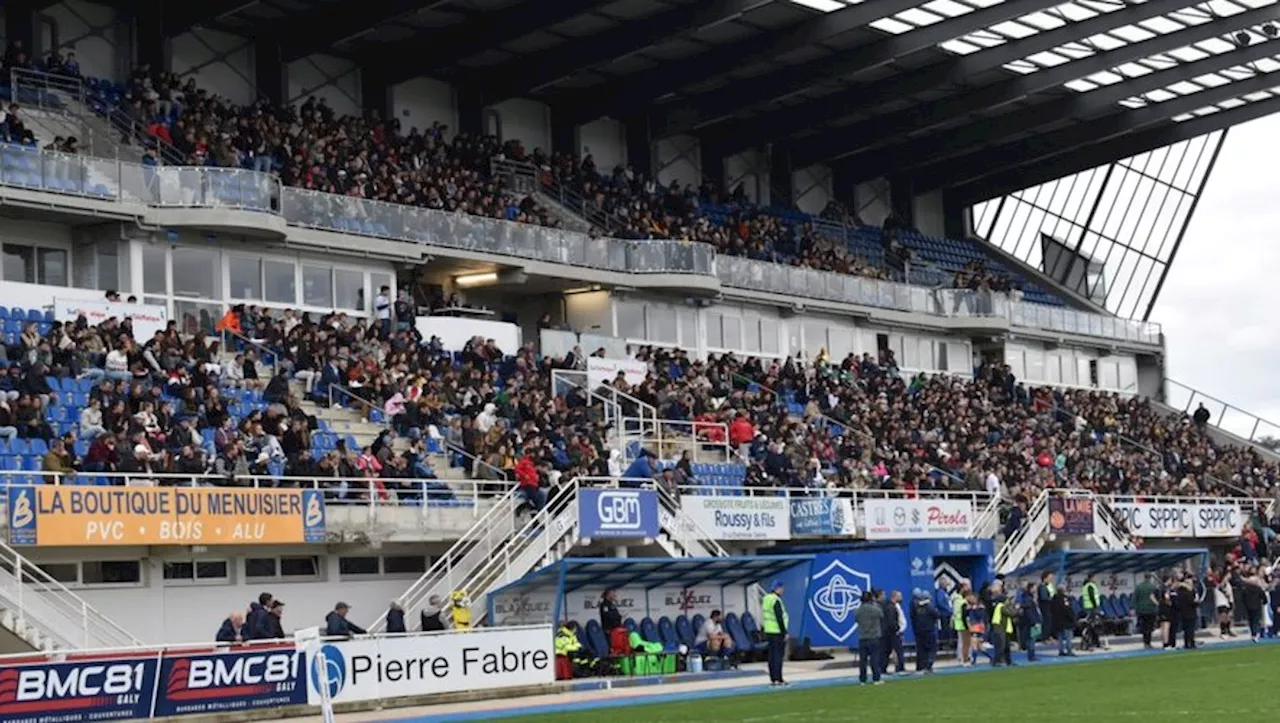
[0,651,160,723]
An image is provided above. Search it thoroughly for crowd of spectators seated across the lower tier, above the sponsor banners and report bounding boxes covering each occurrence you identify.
[0,298,1280,524]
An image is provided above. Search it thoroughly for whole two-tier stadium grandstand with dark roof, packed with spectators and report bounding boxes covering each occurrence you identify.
[0,0,1280,720]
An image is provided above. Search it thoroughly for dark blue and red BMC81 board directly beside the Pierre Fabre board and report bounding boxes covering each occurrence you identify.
[155,645,307,718]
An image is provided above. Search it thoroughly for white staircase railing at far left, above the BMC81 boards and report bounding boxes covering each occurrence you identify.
[0,541,142,648]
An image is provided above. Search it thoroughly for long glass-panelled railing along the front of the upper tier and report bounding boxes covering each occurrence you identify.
[0,145,1162,344]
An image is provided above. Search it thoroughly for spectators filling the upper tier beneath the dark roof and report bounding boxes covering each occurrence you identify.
[0,45,1015,290]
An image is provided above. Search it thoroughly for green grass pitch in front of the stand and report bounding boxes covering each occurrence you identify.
[504,645,1280,723]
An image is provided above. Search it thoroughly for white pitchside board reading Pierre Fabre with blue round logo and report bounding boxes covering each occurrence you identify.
[306,626,556,705]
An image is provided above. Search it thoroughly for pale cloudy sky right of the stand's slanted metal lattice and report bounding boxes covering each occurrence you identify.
[1152,115,1280,438]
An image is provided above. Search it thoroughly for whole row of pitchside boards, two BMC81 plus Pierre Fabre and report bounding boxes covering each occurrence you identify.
[0,626,556,723]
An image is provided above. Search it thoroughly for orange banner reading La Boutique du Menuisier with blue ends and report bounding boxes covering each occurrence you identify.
[8,485,325,546]
